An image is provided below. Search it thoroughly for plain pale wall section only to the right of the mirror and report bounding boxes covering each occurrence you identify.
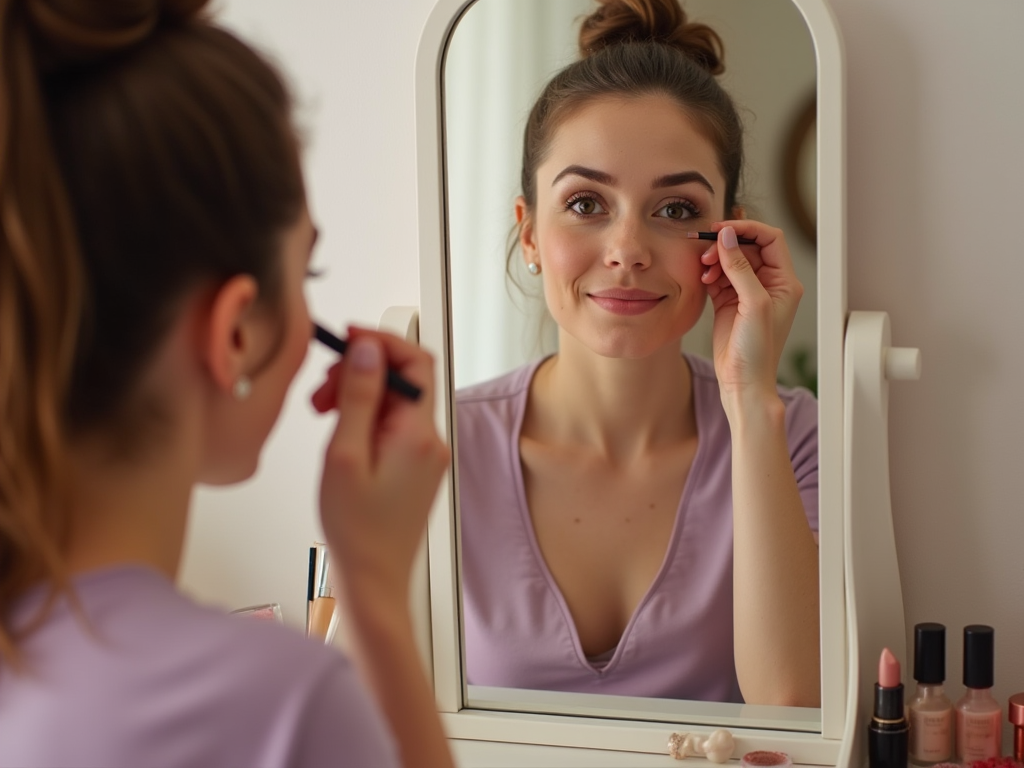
[833,0,1024,744]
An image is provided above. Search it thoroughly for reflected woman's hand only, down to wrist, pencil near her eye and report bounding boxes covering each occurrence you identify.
[700,219,804,397]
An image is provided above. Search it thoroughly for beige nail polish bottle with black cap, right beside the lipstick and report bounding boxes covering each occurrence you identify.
[907,623,953,765]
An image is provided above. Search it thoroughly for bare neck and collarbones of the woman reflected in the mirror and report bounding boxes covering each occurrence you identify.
[527,334,696,461]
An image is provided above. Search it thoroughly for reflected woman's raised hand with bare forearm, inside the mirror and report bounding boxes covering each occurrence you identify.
[700,220,821,707]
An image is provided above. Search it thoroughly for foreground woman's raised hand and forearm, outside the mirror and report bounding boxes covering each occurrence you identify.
[313,329,454,768]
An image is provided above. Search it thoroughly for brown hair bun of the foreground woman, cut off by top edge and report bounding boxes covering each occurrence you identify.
[25,0,207,70]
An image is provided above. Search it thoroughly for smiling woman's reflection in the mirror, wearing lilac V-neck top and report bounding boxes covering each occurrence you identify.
[457,0,819,707]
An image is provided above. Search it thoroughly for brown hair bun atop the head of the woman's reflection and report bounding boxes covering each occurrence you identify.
[580,0,725,75]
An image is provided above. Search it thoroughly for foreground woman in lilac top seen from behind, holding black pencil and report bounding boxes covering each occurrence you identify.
[0,0,452,768]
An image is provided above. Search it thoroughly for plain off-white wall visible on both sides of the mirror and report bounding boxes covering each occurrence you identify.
[182,0,1024,743]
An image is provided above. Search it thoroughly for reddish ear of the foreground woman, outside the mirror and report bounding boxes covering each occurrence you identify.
[202,274,260,392]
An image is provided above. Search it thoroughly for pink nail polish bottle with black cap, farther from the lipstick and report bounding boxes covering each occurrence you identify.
[956,624,1002,763]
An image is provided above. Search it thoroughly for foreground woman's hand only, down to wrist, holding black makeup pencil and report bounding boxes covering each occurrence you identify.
[312,329,450,610]
